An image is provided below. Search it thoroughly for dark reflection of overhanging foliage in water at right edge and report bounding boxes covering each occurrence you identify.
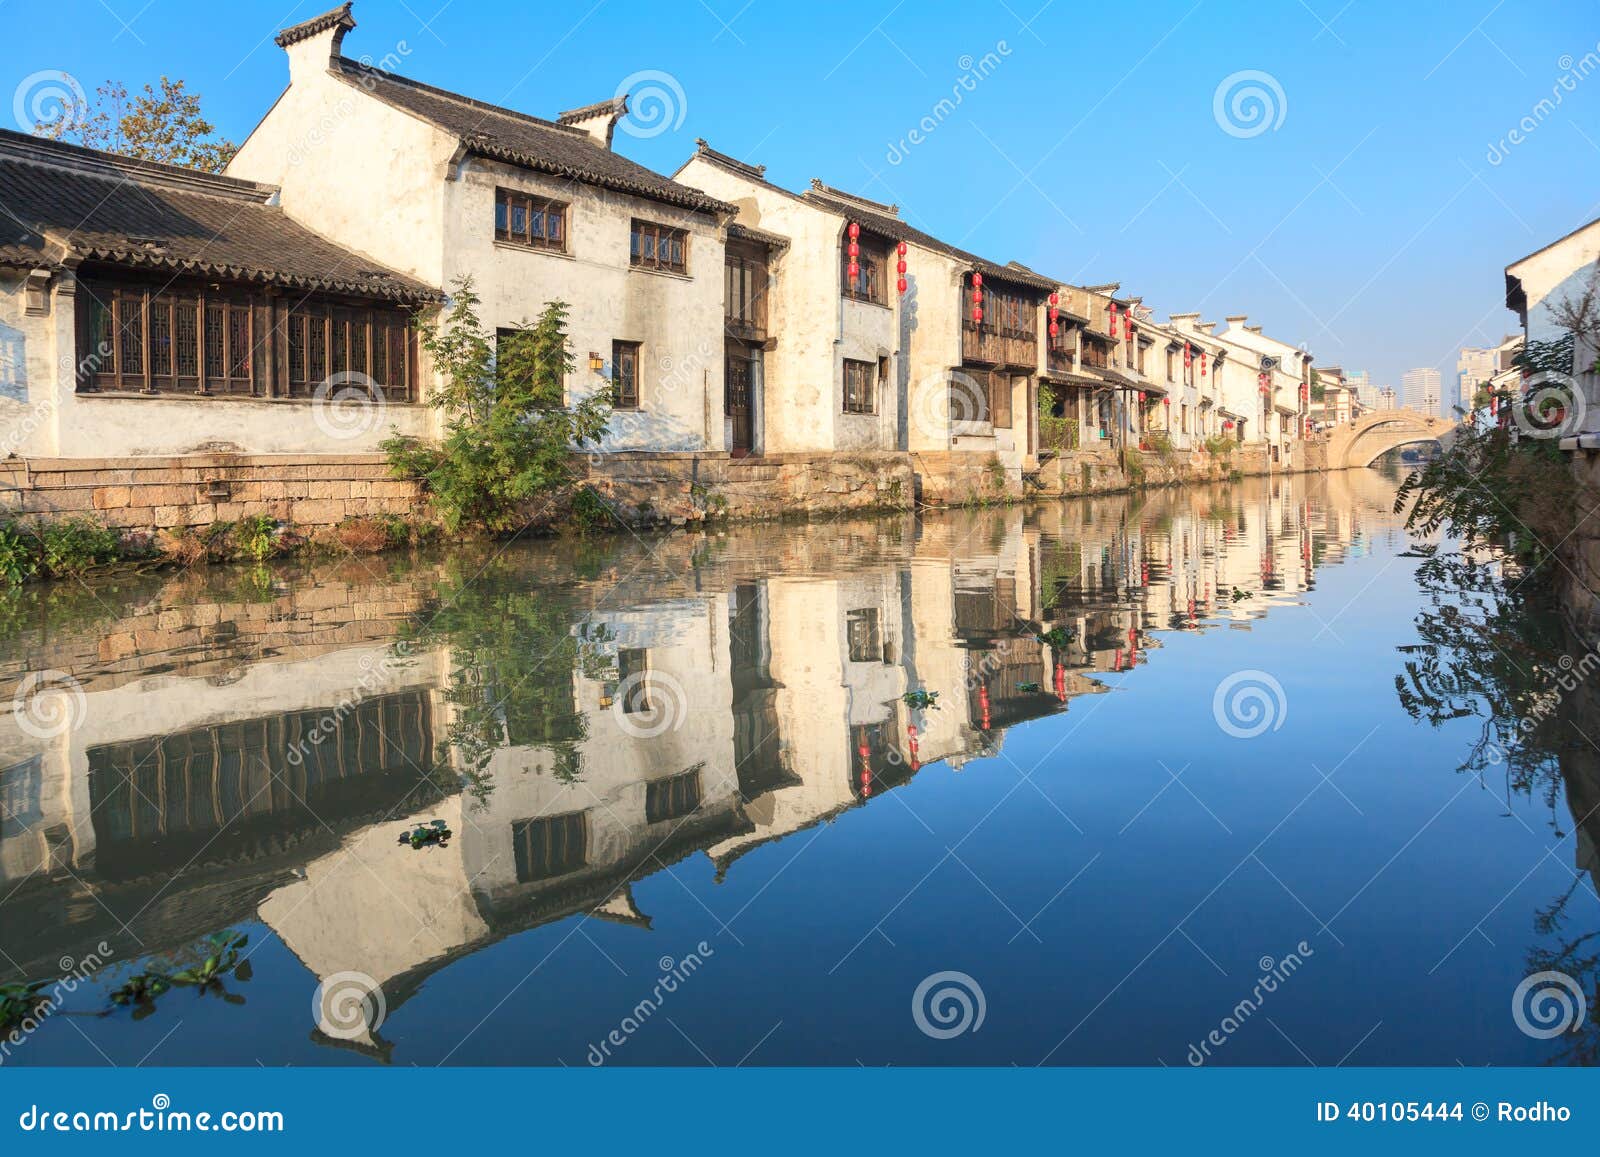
[1395,547,1600,1064]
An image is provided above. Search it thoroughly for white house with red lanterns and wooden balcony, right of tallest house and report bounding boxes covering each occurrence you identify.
[675,141,1056,478]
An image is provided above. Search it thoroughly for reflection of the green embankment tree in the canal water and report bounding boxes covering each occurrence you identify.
[410,558,592,802]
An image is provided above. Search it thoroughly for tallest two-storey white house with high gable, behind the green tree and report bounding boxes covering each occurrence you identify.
[229,5,731,450]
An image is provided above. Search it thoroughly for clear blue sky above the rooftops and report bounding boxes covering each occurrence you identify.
[0,0,1600,393]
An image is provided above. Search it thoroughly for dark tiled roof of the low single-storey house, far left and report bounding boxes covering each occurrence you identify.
[0,130,438,301]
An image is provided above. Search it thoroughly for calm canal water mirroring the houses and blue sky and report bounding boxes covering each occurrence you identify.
[0,470,1600,1066]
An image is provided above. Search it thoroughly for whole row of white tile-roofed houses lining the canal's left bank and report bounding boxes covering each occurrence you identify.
[0,3,1318,528]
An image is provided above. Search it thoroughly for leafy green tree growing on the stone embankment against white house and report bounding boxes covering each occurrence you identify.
[384,278,611,534]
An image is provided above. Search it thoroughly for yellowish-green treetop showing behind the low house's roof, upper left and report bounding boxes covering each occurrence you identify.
[35,77,238,173]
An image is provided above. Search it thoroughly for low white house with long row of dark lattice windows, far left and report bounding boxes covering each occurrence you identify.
[0,122,437,459]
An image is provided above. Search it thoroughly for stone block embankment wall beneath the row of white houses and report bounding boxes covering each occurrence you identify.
[0,442,1326,531]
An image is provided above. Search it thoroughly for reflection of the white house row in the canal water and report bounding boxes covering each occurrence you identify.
[0,475,1392,1048]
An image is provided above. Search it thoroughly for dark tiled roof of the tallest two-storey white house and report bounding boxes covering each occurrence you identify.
[333,56,734,213]
